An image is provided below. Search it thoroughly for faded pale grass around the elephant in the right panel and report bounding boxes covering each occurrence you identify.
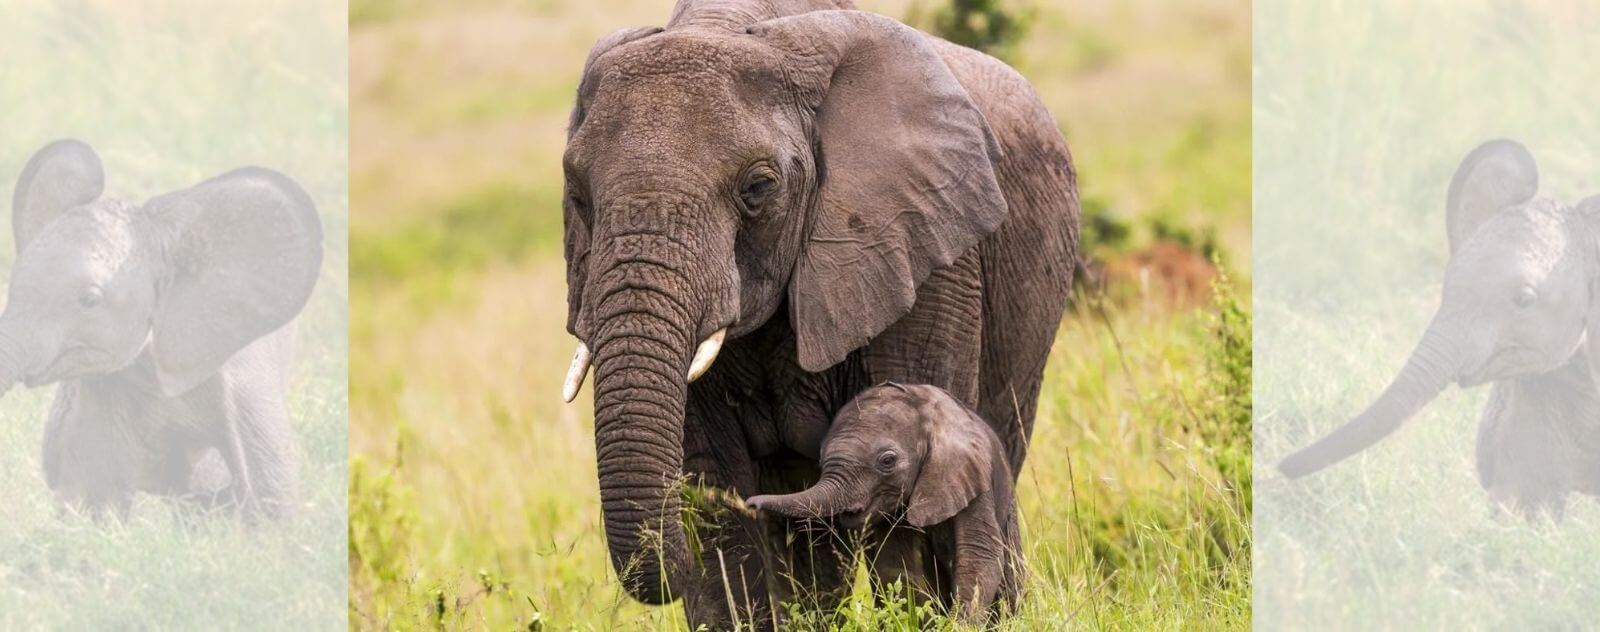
[1254,2,1600,629]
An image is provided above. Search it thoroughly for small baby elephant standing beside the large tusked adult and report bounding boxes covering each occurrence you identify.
[747,382,1021,621]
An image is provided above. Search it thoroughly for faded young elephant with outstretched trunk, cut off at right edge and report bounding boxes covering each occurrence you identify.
[1278,141,1600,515]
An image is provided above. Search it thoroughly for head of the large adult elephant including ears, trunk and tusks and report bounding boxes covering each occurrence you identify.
[563,11,1006,603]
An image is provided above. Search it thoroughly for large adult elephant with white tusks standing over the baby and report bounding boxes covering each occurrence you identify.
[563,0,1078,627]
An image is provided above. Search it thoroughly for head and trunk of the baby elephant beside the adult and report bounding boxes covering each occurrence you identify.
[746,384,1010,539]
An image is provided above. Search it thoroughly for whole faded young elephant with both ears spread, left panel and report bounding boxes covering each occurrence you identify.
[0,141,322,520]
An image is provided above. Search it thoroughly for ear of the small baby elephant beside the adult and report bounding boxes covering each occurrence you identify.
[906,387,995,526]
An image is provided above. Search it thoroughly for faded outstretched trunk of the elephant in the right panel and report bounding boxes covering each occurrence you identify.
[1278,318,1461,478]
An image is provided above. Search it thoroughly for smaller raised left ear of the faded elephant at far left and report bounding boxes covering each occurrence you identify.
[11,139,106,253]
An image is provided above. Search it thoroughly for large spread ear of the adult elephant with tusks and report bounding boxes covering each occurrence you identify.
[749,11,1006,371]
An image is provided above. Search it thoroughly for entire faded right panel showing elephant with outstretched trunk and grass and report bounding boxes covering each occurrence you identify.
[1253,0,1600,630]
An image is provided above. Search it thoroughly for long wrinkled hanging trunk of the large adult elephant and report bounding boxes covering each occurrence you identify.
[594,270,694,603]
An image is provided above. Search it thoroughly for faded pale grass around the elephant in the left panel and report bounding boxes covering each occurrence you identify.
[0,0,349,629]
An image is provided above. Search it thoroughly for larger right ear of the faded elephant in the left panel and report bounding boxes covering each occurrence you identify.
[146,168,322,395]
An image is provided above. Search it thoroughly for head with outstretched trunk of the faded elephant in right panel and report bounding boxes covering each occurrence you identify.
[1278,141,1600,477]
